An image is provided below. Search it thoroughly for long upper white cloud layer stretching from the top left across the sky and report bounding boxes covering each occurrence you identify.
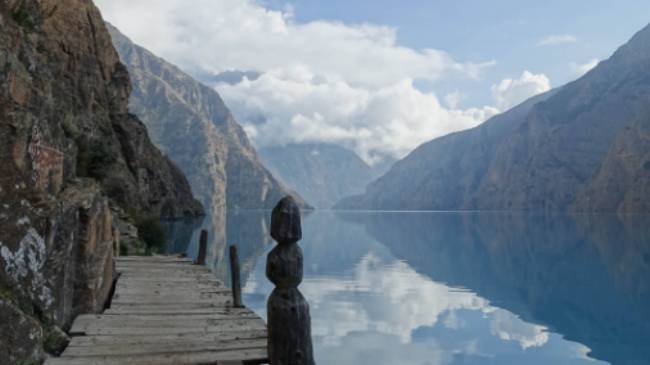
[95,0,491,86]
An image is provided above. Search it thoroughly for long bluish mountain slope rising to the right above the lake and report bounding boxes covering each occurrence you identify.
[338,23,650,213]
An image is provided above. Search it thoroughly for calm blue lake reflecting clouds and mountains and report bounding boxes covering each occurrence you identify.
[169,211,650,365]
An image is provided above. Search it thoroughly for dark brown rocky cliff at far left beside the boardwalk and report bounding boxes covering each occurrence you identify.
[0,0,202,364]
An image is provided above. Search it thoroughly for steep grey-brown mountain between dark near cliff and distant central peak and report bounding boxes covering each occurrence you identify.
[107,24,304,211]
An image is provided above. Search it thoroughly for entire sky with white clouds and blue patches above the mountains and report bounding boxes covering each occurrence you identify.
[95,0,650,164]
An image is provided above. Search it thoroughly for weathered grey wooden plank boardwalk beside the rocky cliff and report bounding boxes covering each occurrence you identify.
[45,256,267,365]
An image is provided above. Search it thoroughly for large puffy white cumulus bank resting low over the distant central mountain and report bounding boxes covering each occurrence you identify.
[218,67,497,163]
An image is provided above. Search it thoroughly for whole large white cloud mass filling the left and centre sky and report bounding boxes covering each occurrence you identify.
[95,0,496,163]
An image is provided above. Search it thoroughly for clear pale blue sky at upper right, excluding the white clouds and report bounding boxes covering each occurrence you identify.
[265,0,650,106]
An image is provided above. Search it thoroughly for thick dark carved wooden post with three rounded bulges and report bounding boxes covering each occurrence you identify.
[266,196,315,365]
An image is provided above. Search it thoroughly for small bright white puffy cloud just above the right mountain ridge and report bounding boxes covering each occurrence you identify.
[492,71,551,111]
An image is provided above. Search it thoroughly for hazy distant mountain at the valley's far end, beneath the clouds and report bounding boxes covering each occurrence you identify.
[259,144,378,208]
